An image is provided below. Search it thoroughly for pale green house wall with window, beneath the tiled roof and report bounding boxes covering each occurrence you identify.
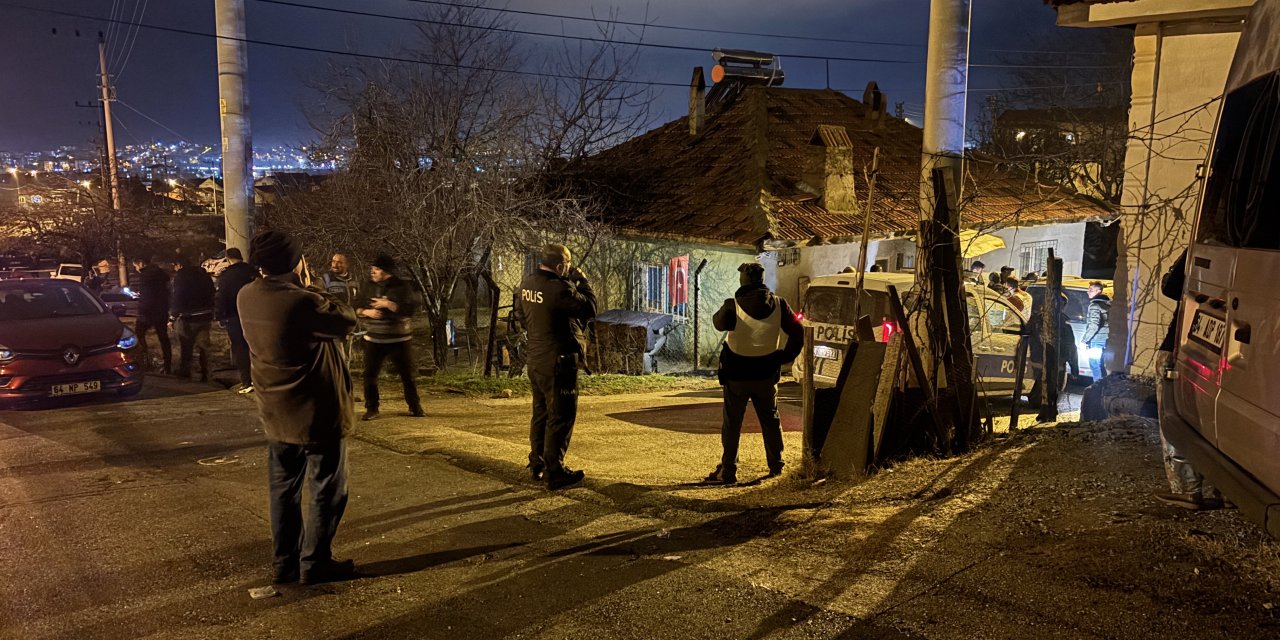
[494,237,752,372]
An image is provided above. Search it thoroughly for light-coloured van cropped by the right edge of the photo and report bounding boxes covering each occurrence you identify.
[1160,0,1280,536]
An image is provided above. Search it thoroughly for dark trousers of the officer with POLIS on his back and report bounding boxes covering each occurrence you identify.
[529,356,577,475]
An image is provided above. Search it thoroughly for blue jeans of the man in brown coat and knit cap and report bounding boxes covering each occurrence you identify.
[268,440,347,575]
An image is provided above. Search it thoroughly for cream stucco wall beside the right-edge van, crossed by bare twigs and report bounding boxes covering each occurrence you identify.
[1107,23,1239,374]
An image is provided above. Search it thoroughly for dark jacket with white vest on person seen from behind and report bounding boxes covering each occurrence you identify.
[712,284,804,381]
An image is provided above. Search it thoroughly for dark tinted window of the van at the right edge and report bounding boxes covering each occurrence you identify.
[1197,73,1280,250]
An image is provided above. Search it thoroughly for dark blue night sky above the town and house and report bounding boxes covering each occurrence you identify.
[0,0,1095,151]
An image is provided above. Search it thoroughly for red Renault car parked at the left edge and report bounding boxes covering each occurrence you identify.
[0,279,142,404]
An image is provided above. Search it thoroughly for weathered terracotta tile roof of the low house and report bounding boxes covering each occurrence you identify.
[577,87,1111,247]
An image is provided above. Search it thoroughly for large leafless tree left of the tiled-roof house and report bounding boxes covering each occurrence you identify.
[271,0,648,366]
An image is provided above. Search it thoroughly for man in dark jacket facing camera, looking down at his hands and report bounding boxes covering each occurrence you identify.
[357,255,426,420]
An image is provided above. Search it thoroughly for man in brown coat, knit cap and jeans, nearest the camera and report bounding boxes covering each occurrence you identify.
[236,232,356,584]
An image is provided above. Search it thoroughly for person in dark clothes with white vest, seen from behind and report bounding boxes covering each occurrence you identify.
[707,262,804,484]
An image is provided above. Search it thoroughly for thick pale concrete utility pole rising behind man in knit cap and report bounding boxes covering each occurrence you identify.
[214,0,253,256]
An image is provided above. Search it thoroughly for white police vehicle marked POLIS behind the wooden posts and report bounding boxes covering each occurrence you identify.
[792,273,1068,396]
